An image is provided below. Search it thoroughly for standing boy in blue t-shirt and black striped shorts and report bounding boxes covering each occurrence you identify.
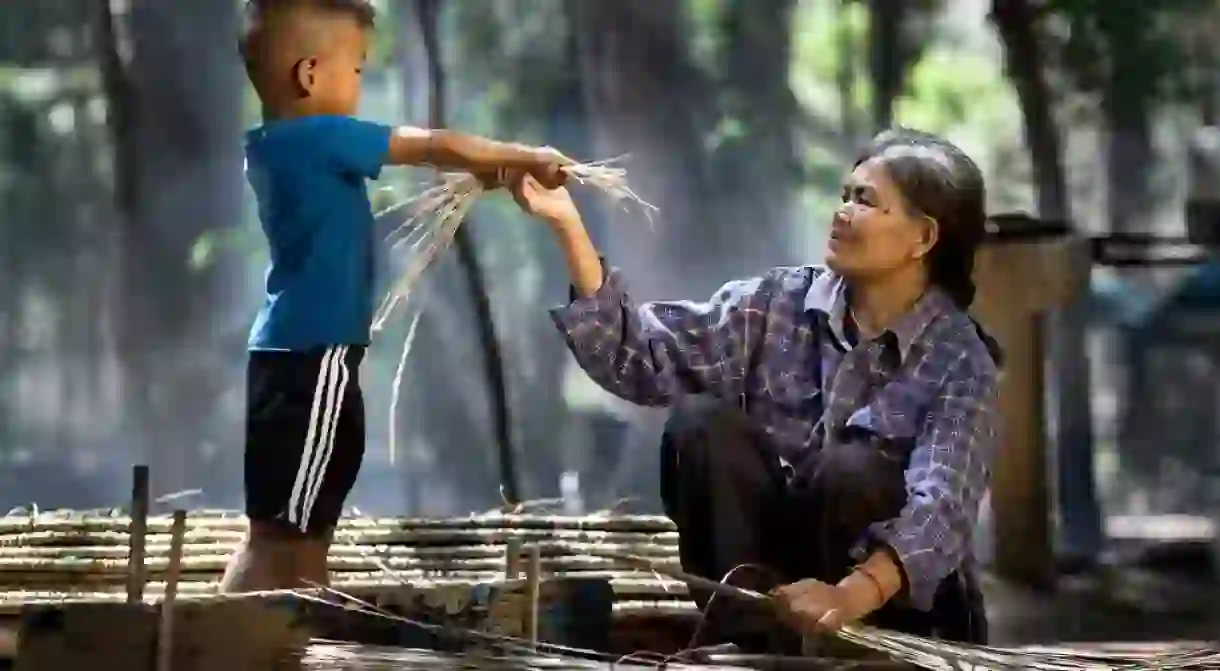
[221,0,569,592]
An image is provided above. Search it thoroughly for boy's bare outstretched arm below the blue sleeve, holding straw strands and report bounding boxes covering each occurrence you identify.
[387,126,572,188]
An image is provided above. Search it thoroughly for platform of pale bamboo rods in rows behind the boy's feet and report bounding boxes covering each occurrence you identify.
[0,510,695,616]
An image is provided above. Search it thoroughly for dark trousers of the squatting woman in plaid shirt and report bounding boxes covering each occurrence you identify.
[661,398,987,643]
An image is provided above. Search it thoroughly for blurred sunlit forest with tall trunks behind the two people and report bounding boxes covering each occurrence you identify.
[0,0,1220,583]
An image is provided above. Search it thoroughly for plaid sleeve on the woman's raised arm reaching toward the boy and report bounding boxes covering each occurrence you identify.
[550,259,769,406]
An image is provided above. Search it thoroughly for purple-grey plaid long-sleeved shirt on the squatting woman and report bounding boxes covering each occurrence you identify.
[551,266,998,611]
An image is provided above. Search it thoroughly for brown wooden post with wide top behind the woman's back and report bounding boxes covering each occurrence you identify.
[975,221,1091,586]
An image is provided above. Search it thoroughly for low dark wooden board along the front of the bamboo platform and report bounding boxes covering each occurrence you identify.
[16,580,612,671]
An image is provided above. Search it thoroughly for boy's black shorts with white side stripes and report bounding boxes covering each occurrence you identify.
[245,345,365,536]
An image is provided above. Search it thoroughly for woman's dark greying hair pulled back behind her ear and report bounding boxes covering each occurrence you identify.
[855,128,987,310]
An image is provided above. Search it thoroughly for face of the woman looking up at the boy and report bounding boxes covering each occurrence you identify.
[826,159,936,277]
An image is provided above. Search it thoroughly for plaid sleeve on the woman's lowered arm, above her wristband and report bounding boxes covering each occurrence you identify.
[869,351,998,611]
